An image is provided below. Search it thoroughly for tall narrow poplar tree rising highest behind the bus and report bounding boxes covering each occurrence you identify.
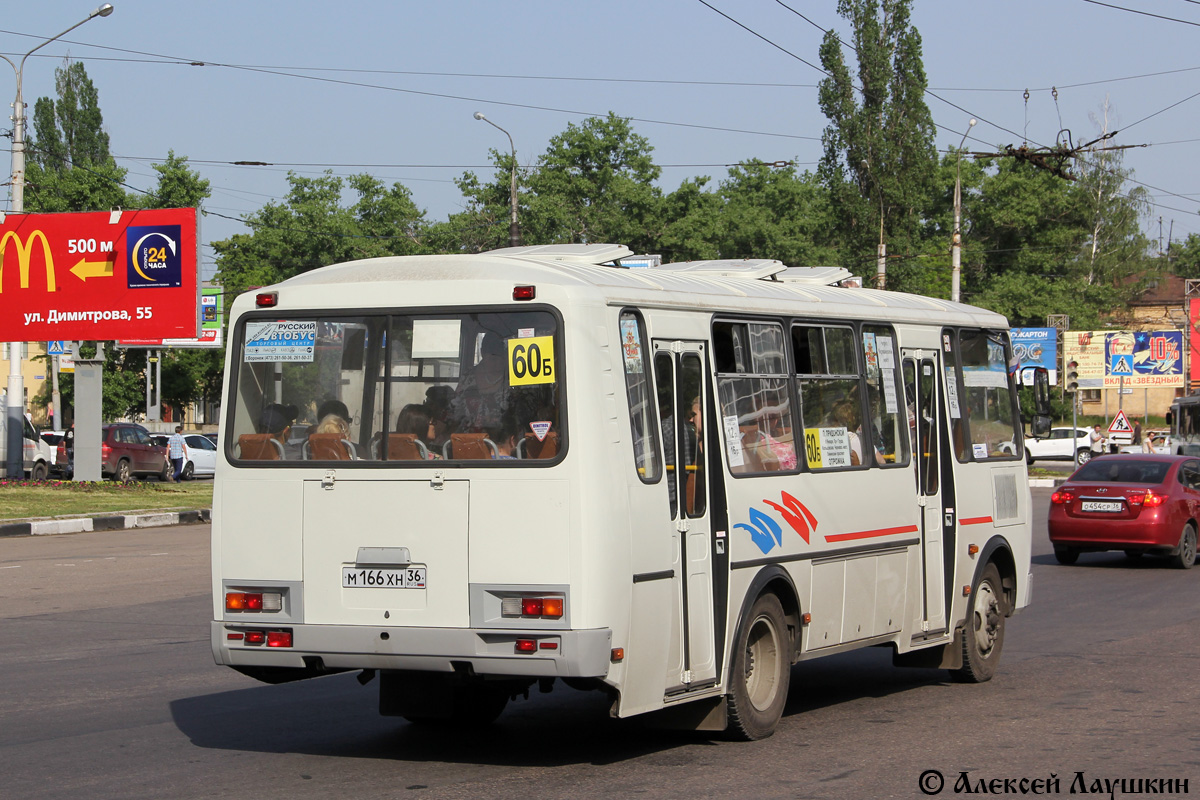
[817,0,937,290]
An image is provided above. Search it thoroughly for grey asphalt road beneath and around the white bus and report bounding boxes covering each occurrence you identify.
[0,489,1200,799]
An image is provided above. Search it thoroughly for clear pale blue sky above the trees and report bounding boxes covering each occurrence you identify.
[0,0,1200,278]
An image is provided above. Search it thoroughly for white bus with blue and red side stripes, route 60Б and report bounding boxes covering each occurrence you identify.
[211,245,1046,739]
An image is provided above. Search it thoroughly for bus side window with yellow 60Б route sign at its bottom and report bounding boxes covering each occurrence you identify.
[792,325,864,469]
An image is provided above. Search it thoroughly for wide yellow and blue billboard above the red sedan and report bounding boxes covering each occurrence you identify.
[1063,330,1183,389]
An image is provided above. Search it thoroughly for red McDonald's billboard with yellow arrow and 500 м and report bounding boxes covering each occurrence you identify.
[0,209,199,342]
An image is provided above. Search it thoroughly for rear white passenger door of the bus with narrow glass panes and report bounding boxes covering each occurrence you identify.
[654,341,716,694]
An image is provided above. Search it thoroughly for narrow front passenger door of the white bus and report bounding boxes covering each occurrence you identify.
[904,350,946,632]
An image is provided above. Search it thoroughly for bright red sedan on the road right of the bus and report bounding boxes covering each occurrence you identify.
[1049,453,1200,570]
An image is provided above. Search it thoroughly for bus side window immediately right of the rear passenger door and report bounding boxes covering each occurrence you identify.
[713,320,798,475]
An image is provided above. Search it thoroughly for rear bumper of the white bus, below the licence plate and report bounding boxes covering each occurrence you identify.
[211,621,612,678]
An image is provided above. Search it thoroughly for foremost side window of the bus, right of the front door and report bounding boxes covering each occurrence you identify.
[955,331,1019,461]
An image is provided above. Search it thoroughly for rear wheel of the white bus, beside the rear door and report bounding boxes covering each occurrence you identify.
[726,594,792,740]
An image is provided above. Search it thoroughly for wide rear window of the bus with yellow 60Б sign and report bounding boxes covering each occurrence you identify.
[227,311,565,464]
